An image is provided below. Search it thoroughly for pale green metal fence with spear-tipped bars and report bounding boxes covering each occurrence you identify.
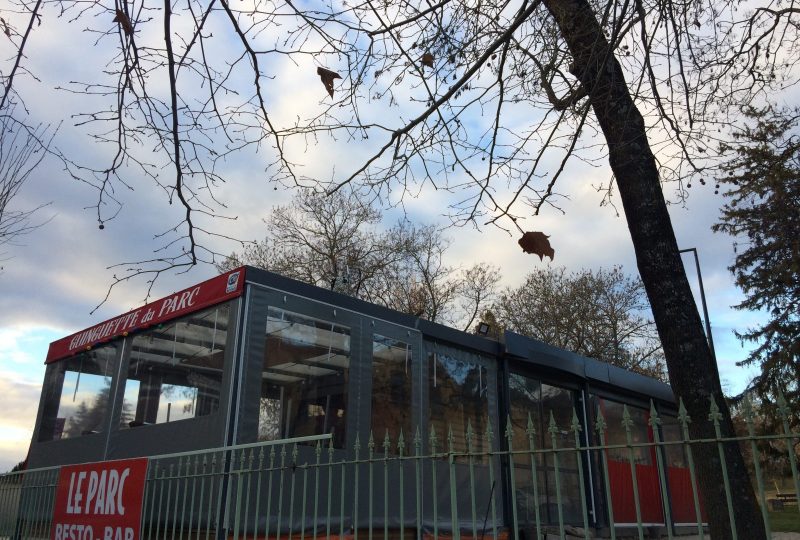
[0,396,800,540]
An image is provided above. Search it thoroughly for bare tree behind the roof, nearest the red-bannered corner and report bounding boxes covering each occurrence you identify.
[218,190,500,329]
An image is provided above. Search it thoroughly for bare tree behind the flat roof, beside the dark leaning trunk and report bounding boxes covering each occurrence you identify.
[492,267,666,380]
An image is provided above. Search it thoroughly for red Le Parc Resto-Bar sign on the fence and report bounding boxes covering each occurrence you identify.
[50,458,147,540]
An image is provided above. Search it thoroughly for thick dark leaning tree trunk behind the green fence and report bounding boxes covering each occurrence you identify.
[543,0,766,540]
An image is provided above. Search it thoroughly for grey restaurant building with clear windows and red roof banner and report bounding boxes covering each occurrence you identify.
[28,267,696,530]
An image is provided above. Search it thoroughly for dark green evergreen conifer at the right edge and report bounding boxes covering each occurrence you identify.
[714,107,800,418]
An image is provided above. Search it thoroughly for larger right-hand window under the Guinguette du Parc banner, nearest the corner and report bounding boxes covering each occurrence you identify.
[120,304,230,427]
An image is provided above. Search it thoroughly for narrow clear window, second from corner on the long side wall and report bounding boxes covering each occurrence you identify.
[370,334,414,453]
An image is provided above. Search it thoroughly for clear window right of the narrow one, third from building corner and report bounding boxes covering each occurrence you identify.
[429,353,490,461]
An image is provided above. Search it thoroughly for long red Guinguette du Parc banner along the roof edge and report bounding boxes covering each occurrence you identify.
[45,268,244,364]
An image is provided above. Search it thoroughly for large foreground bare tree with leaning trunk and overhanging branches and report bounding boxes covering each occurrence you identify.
[1,0,800,528]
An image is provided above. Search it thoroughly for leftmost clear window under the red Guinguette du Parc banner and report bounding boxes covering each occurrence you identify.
[40,345,117,441]
